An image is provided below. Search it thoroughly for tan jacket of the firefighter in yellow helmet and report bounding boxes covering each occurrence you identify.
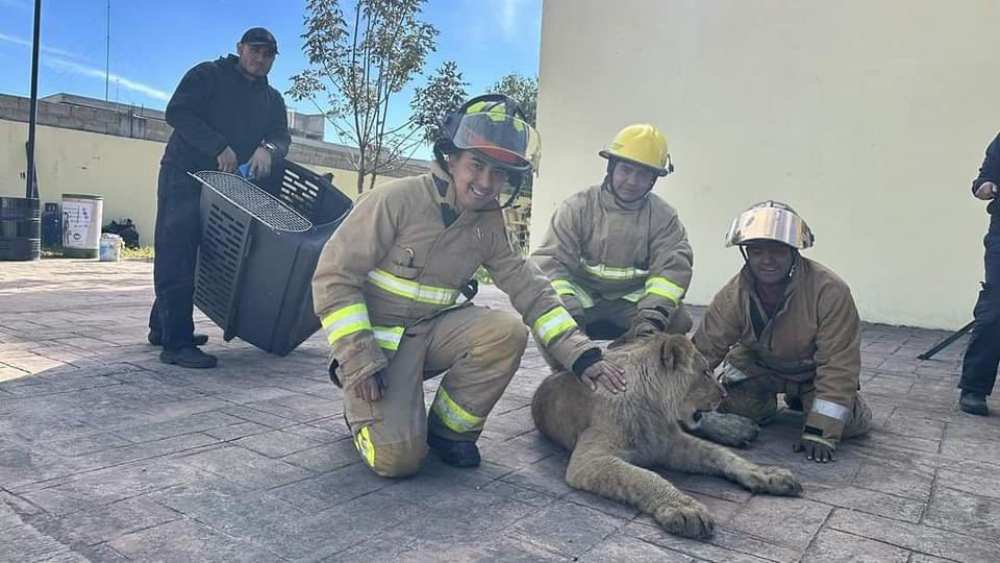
[532,186,694,326]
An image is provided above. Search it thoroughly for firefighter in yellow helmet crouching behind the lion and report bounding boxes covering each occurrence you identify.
[532,124,693,363]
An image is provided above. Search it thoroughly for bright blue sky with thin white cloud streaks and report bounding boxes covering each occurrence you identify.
[0,0,541,143]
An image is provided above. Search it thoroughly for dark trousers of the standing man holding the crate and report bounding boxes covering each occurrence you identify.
[149,165,201,349]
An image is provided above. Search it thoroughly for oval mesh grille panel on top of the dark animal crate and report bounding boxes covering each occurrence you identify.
[191,170,312,233]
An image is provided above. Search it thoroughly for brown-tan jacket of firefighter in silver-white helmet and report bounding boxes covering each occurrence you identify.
[694,256,861,444]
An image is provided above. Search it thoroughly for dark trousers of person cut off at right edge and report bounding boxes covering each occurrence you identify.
[958,213,1000,395]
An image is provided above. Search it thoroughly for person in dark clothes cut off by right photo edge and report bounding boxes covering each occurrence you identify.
[958,135,1000,416]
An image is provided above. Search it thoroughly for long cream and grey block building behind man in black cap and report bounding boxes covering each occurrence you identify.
[0,94,429,245]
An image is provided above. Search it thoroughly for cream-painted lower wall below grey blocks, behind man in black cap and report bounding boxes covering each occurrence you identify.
[0,120,382,245]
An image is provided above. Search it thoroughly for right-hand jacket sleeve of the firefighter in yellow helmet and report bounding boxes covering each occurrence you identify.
[637,210,694,326]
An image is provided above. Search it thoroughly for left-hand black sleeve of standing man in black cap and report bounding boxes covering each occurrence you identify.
[166,63,229,156]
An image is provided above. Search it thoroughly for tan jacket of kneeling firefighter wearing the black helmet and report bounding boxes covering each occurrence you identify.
[313,165,600,389]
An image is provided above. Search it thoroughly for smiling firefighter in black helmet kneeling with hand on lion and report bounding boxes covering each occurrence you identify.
[313,95,625,477]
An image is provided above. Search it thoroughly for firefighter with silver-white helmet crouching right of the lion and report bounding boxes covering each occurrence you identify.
[694,201,872,462]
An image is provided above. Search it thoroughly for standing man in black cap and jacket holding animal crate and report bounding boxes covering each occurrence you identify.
[149,27,291,368]
